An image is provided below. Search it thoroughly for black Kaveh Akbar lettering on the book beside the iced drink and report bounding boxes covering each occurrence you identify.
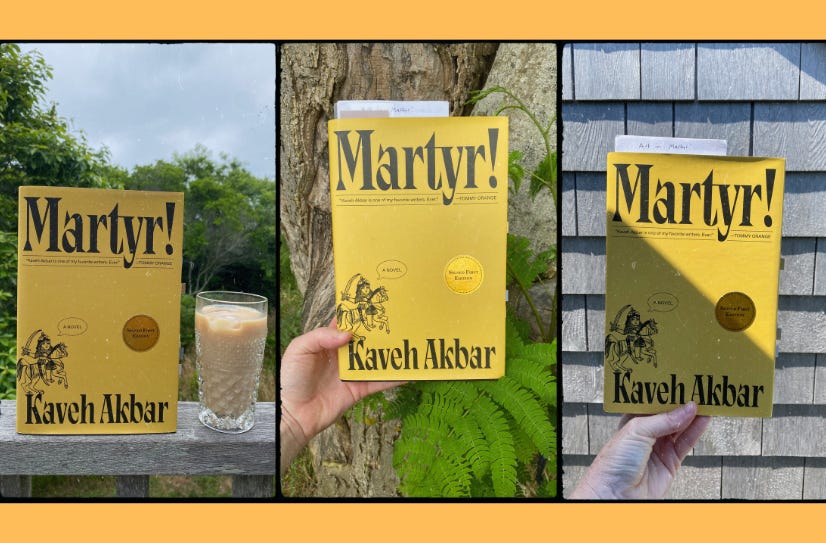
[26,393,169,425]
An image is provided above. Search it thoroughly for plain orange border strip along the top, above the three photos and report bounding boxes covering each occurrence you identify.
[0,0,826,41]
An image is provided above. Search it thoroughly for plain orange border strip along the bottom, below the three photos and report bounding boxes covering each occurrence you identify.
[0,503,826,543]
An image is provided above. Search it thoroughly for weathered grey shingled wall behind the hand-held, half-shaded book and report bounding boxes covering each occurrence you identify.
[561,43,826,500]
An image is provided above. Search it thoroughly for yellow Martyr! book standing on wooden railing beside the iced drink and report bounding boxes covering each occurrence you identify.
[17,186,183,434]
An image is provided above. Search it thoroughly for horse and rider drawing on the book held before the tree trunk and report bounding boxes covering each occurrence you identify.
[336,273,390,341]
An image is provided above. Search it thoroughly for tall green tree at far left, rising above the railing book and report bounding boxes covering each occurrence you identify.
[0,43,109,232]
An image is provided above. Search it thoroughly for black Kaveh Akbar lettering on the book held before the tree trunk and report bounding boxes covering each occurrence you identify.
[348,338,496,371]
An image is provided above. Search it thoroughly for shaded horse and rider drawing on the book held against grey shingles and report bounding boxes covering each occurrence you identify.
[605,305,658,373]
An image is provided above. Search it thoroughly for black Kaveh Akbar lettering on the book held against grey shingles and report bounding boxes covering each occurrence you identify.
[612,371,765,407]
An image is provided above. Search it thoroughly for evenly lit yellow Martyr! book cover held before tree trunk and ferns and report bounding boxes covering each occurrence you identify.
[328,117,508,381]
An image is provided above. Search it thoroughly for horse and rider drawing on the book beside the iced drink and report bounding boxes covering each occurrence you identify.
[17,330,69,396]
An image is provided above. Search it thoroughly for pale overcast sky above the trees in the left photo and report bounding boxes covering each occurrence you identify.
[21,43,275,179]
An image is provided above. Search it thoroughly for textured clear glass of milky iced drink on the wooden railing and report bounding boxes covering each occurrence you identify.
[195,291,267,434]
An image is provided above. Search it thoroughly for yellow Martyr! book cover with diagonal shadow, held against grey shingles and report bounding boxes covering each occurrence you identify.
[604,153,785,417]
